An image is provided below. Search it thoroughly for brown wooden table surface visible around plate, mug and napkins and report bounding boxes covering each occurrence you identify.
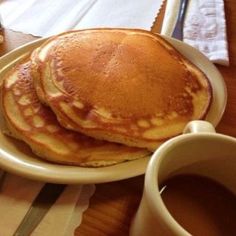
[0,0,236,236]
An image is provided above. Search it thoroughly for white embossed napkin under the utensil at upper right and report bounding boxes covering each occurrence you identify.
[161,0,229,65]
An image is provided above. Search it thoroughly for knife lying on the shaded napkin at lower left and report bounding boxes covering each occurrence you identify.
[13,183,66,236]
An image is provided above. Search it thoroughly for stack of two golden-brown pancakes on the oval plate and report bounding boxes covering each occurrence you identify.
[1,29,212,167]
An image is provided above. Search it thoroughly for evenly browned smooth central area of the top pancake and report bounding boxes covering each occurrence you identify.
[37,31,204,117]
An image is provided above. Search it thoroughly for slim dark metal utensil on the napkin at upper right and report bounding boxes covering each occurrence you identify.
[171,0,188,40]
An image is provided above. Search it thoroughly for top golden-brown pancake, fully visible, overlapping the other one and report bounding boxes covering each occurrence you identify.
[32,29,212,150]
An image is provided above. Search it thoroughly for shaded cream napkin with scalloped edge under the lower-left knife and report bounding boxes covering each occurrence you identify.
[0,171,95,236]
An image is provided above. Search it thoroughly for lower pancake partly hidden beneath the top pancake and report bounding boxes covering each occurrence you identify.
[1,62,149,167]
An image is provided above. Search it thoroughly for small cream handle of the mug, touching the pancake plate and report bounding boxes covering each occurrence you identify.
[183,120,216,134]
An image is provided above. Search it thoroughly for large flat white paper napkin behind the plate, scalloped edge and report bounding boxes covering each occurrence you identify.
[0,0,163,37]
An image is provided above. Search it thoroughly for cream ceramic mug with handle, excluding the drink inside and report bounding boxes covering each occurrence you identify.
[130,121,236,236]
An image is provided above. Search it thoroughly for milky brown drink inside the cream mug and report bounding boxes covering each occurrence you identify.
[160,175,236,236]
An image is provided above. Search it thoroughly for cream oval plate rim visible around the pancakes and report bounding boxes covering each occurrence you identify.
[0,37,227,184]
